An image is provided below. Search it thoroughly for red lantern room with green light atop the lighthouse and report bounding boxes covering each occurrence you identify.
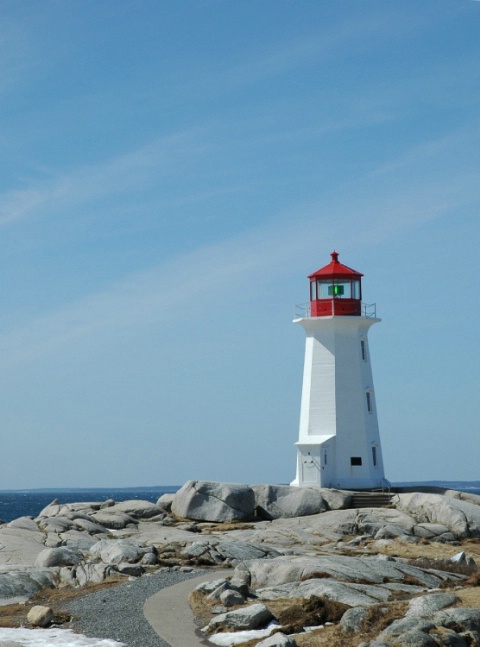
[308,252,363,317]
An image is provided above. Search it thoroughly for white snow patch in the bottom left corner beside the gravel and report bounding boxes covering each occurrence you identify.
[0,627,126,647]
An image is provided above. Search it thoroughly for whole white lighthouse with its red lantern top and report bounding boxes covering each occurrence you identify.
[291,252,385,489]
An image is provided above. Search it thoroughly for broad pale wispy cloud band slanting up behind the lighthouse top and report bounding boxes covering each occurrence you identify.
[0,158,468,371]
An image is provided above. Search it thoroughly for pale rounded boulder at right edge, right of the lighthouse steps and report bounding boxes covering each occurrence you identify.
[396,492,480,538]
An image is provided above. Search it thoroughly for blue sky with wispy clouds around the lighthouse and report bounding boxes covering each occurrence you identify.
[0,0,480,489]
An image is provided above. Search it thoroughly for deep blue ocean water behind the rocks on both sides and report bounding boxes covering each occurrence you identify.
[0,481,480,522]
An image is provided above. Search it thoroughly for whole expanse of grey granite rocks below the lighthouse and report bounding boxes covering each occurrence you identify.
[0,481,480,647]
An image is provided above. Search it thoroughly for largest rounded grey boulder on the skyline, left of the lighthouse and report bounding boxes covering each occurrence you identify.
[172,481,255,523]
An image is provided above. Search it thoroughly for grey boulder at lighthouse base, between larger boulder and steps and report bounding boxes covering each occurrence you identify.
[251,485,328,521]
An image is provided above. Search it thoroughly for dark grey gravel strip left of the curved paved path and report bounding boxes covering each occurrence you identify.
[63,571,202,647]
